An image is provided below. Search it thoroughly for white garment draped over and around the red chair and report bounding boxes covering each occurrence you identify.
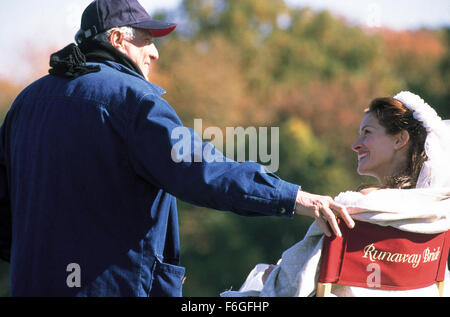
[221,188,450,297]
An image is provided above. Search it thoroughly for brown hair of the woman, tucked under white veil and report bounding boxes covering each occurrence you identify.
[365,97,427,188]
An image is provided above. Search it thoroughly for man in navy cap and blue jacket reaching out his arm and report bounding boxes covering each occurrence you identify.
[0,0,352,296]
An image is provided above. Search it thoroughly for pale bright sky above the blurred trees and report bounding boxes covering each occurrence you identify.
[0,0,450,80]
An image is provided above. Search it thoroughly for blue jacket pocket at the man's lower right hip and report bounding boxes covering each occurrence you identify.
[149,261,186,297]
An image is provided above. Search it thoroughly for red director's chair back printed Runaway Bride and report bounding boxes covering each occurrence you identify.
[316,221,450,297]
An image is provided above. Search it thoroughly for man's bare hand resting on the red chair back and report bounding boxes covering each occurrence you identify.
[295,190,355,237]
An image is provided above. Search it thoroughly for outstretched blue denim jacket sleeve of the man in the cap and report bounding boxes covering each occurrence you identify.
[127,95,299,217]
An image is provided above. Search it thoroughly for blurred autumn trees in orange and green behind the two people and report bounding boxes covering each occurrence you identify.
[0,0,450,296]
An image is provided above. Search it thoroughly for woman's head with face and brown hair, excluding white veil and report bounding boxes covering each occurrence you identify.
[352,98,427,188]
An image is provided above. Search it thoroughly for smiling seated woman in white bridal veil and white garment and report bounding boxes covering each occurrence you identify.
[221,91,450,297]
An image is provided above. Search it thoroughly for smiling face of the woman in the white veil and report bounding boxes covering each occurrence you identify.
[352,113,399,182]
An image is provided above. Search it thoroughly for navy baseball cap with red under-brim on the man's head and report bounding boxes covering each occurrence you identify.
[75,0,177,43]
